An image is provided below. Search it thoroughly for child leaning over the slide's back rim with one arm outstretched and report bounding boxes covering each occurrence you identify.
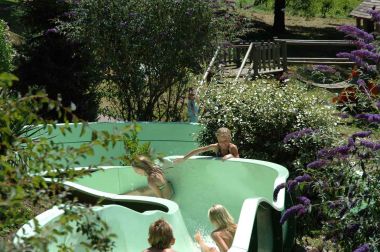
[174,127,239,163]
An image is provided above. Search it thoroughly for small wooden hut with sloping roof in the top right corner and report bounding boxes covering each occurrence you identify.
[350,0,380,32]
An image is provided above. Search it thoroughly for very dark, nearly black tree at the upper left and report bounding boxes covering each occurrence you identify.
[15,0,99,121]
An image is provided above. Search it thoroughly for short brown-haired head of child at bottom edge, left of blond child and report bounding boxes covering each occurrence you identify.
[148,219,175,249]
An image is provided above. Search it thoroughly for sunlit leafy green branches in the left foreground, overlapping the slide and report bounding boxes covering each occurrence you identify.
[0,74,141,251]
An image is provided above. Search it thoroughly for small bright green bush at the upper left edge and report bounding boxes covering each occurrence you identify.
[0,19,15,73]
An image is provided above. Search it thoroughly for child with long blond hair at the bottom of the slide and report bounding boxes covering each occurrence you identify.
[194,205,237,252]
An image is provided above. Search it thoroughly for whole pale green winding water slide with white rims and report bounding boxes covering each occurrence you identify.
[15,123,293,252]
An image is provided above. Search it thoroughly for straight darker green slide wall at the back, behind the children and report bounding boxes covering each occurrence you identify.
[46,122,201,166]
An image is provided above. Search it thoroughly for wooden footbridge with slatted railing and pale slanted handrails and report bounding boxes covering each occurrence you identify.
[201,38,354,84]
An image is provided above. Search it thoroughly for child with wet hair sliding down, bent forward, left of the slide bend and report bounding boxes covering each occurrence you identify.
[126,156,173,199]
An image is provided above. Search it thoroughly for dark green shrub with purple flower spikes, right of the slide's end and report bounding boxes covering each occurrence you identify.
[288,124,380,251]
